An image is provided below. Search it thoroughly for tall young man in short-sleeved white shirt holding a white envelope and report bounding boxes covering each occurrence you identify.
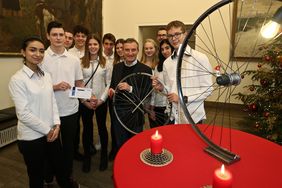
[42,21,84,187]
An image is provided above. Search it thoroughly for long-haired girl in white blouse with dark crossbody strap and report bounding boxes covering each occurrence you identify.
[80,34,111,172]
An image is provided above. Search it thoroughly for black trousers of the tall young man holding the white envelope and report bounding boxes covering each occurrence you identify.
[60,112,78,178]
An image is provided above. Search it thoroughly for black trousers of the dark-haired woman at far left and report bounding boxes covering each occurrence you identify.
[18,136,70,188]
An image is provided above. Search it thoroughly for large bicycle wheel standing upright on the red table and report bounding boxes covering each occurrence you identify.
[177,0,281,164]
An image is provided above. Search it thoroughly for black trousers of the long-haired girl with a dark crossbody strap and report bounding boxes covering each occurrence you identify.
[80,102,108,156]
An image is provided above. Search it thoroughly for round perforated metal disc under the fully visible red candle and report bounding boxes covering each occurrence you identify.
[140,148,173,167]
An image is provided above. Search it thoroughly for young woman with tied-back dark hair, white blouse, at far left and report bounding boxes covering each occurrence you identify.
[9,36,71,188]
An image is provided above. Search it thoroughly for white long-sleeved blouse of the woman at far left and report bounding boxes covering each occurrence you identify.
[9,65,60,140]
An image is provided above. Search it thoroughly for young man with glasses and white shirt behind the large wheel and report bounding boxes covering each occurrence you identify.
[153,20,212,124]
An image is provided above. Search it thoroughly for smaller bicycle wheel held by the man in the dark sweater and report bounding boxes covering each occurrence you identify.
[113,72,171,134]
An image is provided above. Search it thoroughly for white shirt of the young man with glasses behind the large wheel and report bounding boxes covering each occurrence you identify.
[163,46,213,123]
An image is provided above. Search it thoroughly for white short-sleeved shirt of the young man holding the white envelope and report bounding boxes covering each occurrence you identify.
[42,47,83,117]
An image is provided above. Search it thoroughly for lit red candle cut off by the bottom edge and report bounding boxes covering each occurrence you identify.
[212,165,232,188]
